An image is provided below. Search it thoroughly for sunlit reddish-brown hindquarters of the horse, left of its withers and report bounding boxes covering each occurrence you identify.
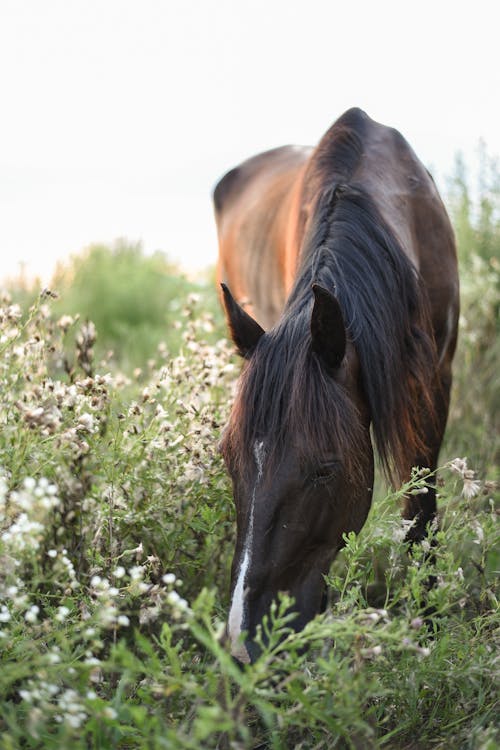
[214,146,312,328]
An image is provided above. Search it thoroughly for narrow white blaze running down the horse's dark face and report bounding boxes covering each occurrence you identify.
[227,441,264,663]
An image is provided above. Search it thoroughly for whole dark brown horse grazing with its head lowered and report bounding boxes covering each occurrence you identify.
[214,109,459,662]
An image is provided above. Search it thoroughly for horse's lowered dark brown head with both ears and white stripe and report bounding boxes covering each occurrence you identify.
[222,285,373,662]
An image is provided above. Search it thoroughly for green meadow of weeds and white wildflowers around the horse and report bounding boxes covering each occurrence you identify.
[0,160,500,750]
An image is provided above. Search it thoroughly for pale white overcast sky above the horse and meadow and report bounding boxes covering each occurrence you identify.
[0,0,500,283]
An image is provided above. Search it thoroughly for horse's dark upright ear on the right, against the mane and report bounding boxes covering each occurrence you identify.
[311,284,346,370]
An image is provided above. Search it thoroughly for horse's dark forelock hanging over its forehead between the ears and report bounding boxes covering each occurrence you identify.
[222,303,362,488]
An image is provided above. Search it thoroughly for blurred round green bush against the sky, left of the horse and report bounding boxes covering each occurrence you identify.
[51,241,221,364]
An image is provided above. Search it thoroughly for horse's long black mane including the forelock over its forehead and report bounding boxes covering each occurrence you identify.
[222,119,437,484]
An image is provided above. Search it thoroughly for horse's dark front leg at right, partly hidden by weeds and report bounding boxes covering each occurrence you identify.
[403,367,451,543]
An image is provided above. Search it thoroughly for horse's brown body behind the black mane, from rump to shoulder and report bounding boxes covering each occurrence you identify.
[214,108,459,362]
